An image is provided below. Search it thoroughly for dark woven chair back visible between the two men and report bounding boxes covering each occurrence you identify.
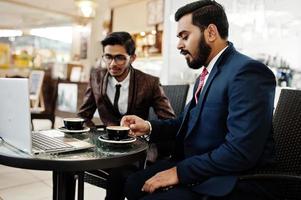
[148,84,189,120]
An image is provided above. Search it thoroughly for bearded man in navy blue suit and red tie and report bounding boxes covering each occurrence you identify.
[121,0,276,200]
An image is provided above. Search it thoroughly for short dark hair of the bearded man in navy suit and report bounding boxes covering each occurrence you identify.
[175,0,229,39]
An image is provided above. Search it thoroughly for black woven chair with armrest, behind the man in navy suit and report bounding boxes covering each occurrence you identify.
[240,89,301,200]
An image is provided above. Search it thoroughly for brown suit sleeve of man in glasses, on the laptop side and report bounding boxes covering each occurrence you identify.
[77,76,97,126]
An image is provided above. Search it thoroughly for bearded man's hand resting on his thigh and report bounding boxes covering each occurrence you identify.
[142,167,179,193]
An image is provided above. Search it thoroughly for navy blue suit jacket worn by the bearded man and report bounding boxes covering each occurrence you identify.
[150,43,276,196]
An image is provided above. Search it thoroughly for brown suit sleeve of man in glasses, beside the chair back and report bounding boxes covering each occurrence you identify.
[152,78,175,119]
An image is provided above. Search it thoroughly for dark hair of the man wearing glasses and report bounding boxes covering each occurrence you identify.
[101,32,136,55]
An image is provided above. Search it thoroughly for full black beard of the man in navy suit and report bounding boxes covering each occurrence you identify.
[186,34,211,69]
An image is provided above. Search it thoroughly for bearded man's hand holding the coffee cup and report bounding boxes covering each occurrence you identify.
[120,115,150,136]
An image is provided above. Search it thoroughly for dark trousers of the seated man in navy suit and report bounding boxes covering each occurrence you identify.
[125,161,277,200]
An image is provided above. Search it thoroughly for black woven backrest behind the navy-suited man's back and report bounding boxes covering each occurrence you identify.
[273,89,301,175]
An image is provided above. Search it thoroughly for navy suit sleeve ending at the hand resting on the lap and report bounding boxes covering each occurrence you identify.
[177,62,275,184]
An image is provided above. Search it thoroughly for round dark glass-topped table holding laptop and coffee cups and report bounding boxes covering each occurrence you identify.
[0,130,148,200]
